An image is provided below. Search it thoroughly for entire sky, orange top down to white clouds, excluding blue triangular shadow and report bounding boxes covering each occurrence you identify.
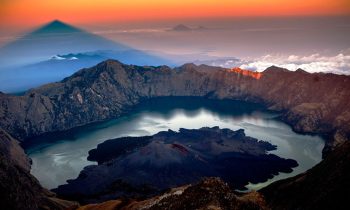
[0,0,350,83]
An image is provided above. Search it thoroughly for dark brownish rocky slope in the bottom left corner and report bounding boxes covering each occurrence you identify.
[0,129,78,210]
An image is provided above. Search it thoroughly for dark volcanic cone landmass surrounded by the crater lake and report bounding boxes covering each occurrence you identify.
[54,127,298,203]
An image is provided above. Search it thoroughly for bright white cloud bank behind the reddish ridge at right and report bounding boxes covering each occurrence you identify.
[240,50,350,75]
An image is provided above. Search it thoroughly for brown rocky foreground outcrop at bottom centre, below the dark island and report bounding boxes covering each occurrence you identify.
[78,178,269,210]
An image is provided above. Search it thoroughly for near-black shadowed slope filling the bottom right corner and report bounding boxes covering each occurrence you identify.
[261,142,350,210]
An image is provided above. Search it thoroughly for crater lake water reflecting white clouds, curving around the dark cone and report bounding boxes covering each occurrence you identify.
[25,97,324,189]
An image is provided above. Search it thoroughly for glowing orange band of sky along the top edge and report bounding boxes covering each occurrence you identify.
[0,0,350,27]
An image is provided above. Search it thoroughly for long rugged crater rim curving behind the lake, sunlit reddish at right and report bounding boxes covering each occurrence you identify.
[0,60,350,155]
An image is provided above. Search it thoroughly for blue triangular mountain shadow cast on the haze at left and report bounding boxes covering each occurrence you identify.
[0,20,172,92]
